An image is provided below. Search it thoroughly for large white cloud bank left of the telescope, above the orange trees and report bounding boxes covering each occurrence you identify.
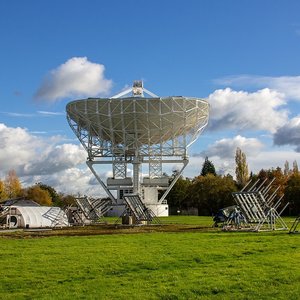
[0,124,97,193]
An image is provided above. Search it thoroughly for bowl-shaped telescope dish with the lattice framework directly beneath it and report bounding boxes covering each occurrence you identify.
[67,97,208,160]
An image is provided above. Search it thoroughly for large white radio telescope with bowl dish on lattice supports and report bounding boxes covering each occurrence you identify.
[66,81,209,216]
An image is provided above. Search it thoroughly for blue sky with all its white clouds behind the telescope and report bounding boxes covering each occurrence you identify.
[0,0,300,196]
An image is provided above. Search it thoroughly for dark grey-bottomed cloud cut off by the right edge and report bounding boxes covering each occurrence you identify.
[273,116,300,152]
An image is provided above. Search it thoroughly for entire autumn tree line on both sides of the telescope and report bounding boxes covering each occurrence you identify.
[0,148,300,215]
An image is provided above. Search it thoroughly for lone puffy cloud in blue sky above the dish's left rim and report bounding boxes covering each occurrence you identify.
[35,57,112,102]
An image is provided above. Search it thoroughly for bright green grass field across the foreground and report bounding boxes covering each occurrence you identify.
[0,217,300,299]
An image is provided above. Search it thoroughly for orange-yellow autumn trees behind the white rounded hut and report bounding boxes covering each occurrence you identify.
[0,170,75,207]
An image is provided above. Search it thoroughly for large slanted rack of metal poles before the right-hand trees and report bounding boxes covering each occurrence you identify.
[230,178,289,231]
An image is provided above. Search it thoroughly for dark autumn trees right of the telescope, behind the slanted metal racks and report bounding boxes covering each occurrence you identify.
[167,148,300,215]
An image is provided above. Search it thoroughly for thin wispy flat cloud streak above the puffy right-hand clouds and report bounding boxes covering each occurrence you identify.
[215,75,300,101]
